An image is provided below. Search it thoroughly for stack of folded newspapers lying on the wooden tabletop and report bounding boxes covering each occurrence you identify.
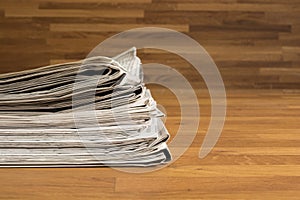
[0,48,171,167]
